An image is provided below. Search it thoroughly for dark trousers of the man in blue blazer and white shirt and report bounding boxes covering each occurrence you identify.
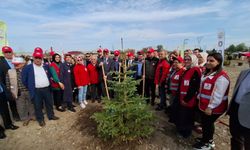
[33,87,54,122]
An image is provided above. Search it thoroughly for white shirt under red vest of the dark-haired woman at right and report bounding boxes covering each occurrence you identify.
[201,73,229,109]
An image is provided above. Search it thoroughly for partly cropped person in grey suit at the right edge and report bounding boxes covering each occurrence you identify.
[227,53,250,150]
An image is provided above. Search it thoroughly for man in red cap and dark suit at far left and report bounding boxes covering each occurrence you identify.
[0,46,20,121]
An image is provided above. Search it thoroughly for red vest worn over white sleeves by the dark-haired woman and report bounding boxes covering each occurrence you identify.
[199,71,229,114]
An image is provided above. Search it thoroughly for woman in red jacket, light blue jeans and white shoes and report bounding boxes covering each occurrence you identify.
[74,56,90,109]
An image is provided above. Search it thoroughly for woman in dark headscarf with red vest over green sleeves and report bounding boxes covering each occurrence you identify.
[50,53,65,112]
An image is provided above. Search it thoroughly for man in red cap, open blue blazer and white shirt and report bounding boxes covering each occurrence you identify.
[22,48,59,127]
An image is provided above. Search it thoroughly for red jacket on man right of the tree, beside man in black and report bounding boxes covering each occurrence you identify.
[155,59,170,84]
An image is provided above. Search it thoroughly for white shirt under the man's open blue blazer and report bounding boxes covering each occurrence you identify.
[33,64,49,88]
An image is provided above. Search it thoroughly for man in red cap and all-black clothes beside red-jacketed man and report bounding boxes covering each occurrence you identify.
[143,48,159,106]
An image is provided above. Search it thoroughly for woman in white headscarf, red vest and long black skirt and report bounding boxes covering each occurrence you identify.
[176,54,201,138]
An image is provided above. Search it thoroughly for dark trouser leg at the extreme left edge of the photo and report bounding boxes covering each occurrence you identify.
[0,94,12,128]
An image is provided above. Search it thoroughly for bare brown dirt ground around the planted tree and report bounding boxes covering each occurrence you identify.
[0,61,248,150]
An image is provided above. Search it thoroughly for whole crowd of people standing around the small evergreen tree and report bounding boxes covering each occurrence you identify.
[0,46,250,149]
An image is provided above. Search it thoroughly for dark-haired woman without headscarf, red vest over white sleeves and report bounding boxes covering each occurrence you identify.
[193,53,230,149]
